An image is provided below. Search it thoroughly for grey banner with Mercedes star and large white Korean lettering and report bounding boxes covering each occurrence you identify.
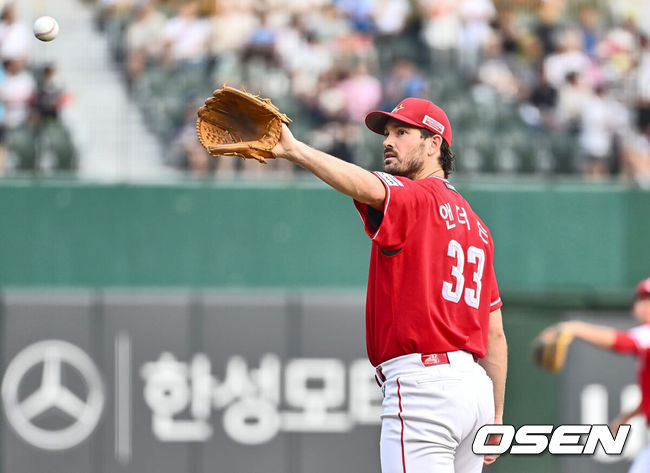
[2,291,381,473]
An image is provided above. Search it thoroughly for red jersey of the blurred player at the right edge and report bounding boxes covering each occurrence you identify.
[613,325,650,424]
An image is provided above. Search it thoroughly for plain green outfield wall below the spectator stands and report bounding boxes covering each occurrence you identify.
[0,181,650,296]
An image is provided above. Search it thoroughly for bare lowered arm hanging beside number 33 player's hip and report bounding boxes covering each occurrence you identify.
[479,309,508,465]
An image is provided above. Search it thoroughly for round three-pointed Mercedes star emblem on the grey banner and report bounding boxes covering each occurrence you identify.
[2,340,104,450]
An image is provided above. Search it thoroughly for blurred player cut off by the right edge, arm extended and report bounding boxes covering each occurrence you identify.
[548,278,650,473]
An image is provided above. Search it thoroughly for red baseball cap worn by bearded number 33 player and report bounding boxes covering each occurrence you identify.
[366,97,451,146]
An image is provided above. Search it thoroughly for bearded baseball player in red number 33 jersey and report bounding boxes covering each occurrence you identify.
[273,98,507,473]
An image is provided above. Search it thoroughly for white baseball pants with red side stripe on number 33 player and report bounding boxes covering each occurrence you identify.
[379,351,494,473]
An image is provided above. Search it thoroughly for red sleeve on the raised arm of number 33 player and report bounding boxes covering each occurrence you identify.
[354,172,424,249]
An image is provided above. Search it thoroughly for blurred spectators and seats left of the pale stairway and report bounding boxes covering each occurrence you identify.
[0,3,76,176]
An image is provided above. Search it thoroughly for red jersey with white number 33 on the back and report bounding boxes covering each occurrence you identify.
[354,172,502,366]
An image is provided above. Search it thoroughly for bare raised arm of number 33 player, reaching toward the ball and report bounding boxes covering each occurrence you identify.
[273,125,386,210]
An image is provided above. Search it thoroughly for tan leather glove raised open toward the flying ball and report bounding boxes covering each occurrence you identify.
[196,84,291,163]
